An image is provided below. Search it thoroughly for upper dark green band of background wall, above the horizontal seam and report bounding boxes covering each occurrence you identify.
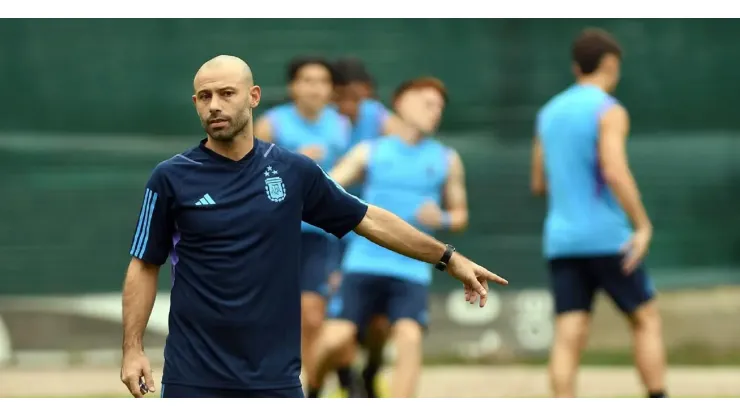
[0,19,740,136]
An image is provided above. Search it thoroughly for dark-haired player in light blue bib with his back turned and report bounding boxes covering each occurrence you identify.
[532,29,666,397]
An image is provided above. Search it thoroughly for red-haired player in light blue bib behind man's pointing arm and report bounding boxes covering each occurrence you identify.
[309,78,468,397]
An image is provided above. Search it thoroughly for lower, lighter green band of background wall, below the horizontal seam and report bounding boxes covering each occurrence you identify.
[0,135,740,293]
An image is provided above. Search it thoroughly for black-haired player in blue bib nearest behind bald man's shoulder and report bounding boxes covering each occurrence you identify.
[255,57,350,390]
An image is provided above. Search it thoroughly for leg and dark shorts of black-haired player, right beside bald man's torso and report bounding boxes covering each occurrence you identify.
[300,232,331,384]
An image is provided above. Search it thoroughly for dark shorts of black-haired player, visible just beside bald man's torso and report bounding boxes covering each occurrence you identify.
[300,232,336,296]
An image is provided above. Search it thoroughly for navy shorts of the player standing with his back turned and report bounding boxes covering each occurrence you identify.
[549,255,655,314]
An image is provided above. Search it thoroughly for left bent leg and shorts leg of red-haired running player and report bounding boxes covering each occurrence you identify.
[308,274,377,397]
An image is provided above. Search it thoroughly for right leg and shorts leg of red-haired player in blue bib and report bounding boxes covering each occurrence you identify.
[387,278,428,397]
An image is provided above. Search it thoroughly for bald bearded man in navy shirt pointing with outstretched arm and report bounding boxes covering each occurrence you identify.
[121,56,506,398]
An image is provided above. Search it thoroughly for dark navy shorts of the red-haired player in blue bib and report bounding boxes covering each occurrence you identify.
[327,273,429,332]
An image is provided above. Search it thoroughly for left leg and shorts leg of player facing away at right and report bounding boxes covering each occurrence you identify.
[548,259,598,397]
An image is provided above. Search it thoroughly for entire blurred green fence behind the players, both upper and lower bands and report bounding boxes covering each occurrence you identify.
[0,19,740,293]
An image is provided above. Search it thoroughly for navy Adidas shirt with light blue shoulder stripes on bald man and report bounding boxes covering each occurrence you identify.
[131,139,367,389]
